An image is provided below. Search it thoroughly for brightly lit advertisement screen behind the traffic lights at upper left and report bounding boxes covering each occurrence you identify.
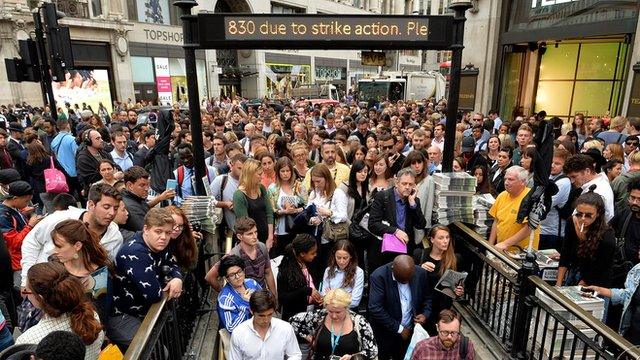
[52,69,112,112]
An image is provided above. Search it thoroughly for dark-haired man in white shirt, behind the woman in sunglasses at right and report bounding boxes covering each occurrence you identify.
[563,154,614,222]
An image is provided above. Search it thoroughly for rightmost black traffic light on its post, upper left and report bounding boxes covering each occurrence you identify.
[42,3,73,81]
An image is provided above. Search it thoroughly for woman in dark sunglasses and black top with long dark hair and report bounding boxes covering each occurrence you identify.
[556,190,616,287]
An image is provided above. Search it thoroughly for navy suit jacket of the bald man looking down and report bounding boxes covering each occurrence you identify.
[369,263,433,334]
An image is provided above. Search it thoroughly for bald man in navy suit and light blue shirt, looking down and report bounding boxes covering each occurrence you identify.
[369,255,433,360]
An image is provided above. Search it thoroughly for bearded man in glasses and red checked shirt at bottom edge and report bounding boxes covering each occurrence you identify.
[411,310,475,360]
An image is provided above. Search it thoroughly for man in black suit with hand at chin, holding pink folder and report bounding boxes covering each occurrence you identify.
[368,168,427,271]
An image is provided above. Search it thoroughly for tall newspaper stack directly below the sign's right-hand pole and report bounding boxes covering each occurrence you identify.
[433,172,477,225]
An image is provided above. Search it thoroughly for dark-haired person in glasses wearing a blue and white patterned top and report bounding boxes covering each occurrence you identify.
[218,255,262,333]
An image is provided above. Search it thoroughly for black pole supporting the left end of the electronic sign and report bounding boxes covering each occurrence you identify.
[173,0,207,195]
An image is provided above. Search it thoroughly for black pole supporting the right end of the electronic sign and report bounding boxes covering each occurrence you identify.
[442,2,472,172]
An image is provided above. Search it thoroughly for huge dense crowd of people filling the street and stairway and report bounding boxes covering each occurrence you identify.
[0,98,640,360]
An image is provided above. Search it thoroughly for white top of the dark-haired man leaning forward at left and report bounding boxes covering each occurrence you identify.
[20,206,122,286]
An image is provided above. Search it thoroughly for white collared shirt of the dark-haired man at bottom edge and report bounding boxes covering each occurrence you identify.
[229,318,302,360]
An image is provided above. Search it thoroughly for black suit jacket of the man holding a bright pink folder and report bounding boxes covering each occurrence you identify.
[369,187,427,241]
